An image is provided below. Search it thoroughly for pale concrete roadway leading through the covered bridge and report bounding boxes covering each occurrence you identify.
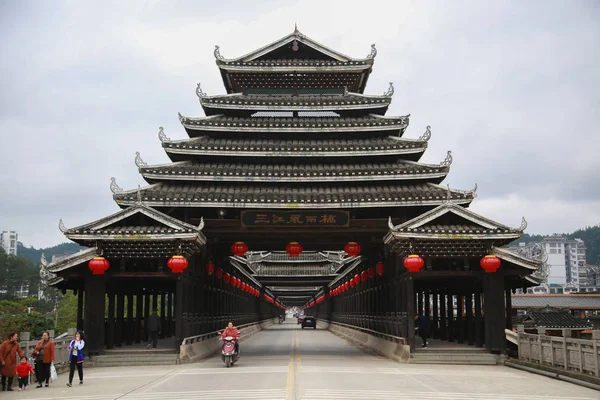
[5,320,600,400]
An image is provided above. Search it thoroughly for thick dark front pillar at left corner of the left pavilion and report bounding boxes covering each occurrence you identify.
[83,273,106,354]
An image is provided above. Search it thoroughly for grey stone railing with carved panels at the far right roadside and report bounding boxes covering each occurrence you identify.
[518,331,600,377]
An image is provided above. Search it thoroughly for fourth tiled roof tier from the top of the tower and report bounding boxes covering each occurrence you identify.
[163,136,427,156]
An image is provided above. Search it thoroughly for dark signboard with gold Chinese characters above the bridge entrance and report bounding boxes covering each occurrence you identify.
[242,210,350,228]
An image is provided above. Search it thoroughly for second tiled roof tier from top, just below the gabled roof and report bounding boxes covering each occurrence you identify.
[201,94,392,110]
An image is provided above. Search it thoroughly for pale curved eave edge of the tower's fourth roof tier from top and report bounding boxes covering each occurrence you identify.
[163,144,427,157]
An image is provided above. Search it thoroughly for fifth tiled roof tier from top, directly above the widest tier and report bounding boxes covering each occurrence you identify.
[140,162,449,182]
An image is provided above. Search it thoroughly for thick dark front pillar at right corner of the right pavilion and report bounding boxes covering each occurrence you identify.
[483,271,506,354]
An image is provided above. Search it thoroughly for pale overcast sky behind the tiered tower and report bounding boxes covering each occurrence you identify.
[0,0,600,247]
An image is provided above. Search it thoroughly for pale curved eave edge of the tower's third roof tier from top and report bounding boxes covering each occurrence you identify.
[182,122,408,135]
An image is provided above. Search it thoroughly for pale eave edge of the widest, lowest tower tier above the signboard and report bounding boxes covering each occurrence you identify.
[113,195,473,209]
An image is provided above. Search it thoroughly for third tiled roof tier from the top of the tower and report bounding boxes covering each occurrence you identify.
[179,114,409,132]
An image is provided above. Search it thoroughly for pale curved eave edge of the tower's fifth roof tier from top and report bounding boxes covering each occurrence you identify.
[142,172,448,183]
